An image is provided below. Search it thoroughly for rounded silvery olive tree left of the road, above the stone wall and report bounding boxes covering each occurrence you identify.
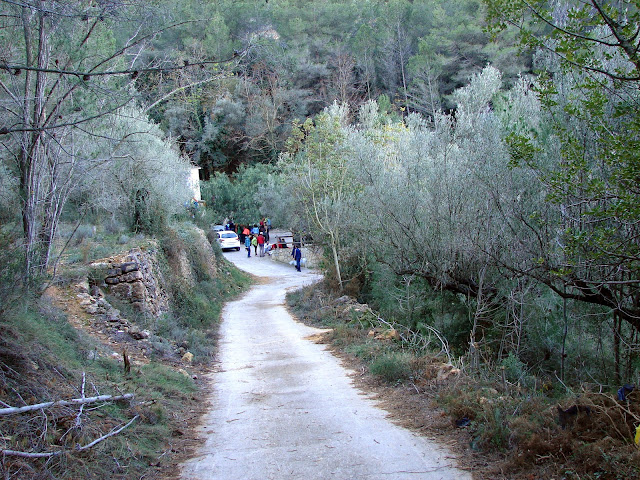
[71,106,193,233]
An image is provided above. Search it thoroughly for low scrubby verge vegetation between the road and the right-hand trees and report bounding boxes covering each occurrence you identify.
[287,283,640,480]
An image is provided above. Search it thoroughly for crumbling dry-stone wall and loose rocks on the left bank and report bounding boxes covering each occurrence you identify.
[48,230,217,368]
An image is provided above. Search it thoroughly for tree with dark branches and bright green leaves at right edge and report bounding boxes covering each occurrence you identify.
[485,0,640,329]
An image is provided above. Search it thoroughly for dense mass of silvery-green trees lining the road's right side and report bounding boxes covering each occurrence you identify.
[281,55,638,382]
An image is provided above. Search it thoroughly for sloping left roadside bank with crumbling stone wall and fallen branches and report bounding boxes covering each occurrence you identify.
[0,224,248,479]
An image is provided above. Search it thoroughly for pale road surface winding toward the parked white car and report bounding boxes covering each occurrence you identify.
[182,249,471,480]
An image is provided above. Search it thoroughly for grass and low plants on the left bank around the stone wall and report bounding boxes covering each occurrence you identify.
[0,220,250,479]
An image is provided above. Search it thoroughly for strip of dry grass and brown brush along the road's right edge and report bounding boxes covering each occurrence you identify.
[290,282,640,480]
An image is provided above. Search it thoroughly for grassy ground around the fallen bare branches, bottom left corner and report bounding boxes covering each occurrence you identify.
[0,301,197,479]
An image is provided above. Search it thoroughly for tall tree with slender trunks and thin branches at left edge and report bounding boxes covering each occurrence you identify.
[0,0,237,279]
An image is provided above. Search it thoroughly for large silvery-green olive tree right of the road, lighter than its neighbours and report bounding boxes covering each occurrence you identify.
[340,67,555,360]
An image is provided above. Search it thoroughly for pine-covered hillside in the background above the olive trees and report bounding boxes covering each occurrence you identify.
[136,0,531,175]
